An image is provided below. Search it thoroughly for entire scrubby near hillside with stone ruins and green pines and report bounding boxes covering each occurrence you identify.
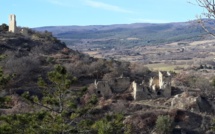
[0,24,215,134]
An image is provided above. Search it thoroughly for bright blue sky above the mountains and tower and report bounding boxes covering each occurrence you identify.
[0,0,204,28]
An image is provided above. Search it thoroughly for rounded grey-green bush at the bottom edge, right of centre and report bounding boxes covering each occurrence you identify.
[155,115,173,134]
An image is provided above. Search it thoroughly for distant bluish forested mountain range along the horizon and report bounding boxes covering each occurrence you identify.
[35,19,215,46]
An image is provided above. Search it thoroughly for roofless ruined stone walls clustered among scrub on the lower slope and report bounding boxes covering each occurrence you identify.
[94,71,171,101]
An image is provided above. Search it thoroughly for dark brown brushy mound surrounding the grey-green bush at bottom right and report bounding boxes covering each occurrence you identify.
[124,109,212,134]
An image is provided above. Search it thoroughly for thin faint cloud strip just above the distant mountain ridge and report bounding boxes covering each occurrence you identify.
[129,18,170,23]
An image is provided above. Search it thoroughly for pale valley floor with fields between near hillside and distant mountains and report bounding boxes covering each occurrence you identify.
[70,40,215,72]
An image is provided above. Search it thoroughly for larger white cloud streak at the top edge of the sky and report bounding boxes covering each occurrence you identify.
[84,0,134,13]
